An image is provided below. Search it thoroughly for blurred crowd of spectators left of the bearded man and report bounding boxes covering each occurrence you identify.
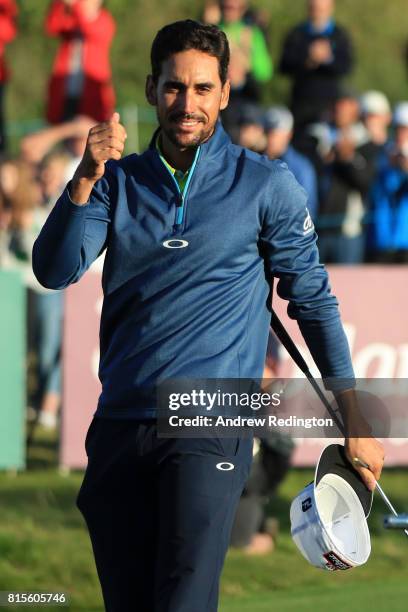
[0,0,116,428]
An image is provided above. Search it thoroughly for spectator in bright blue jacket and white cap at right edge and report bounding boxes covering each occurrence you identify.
[369,102,408,263]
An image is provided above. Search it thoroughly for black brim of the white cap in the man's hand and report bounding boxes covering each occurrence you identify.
[315,444,373,518]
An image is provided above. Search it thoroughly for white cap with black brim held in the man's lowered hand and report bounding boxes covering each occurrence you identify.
[290,444,372,571]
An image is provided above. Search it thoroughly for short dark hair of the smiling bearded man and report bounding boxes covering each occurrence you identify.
[150,19,230,85]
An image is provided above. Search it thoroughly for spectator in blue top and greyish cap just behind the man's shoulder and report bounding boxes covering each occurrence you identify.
[264,106,318,219]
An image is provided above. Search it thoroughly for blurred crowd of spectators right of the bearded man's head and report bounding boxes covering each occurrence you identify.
[203,0,408,264]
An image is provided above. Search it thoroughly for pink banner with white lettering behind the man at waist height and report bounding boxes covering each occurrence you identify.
[60,266,408,468]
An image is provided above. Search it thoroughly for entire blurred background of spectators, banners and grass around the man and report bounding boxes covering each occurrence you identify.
[0,0,408,612]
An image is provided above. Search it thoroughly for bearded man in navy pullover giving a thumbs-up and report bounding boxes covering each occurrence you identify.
[33,20,383,612]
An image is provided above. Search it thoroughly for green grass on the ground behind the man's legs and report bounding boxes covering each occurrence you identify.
[0,431,408,612]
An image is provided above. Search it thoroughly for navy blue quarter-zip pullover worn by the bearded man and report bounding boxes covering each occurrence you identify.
[33,123,353,419]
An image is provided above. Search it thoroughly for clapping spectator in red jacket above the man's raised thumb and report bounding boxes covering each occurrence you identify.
[46,0,116,123]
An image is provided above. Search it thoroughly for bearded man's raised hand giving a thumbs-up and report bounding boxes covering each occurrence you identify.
[70,113,127,204]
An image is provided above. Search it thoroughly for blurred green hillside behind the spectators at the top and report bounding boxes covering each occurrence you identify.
[6,0,407,144]
